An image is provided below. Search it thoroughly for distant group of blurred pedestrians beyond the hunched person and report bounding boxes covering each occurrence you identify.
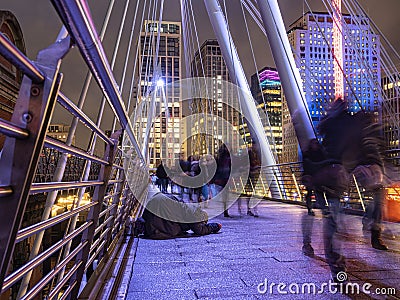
[151,141,261,218]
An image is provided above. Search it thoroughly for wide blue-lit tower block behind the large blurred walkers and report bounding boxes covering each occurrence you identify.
[283,13,382,162]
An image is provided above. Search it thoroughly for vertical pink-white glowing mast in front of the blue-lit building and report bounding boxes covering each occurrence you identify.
[332,0,344,100]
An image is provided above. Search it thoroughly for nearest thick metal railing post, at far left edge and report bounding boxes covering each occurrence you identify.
[0,38,70,286]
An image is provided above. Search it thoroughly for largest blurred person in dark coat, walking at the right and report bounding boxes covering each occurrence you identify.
[318,99,387,275]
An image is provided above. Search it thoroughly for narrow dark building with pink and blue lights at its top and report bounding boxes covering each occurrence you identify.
[250,67,282,161]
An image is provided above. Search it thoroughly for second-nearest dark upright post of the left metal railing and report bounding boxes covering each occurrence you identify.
[67,136,118,299]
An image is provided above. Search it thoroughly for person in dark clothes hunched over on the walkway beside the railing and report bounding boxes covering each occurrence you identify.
[143,193,222,239]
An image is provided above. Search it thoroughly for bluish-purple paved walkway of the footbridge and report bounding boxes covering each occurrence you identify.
[119,197,400,300]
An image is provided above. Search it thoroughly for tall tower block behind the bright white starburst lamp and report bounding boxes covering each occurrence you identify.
[134,21,182,169]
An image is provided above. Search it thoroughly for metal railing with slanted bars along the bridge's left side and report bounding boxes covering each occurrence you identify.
[0,1,148,299]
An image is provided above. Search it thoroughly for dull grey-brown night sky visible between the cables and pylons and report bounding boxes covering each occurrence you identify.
[1,0,400,148]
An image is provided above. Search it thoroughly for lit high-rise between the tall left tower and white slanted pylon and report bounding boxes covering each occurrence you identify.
[189,40,240,154]
